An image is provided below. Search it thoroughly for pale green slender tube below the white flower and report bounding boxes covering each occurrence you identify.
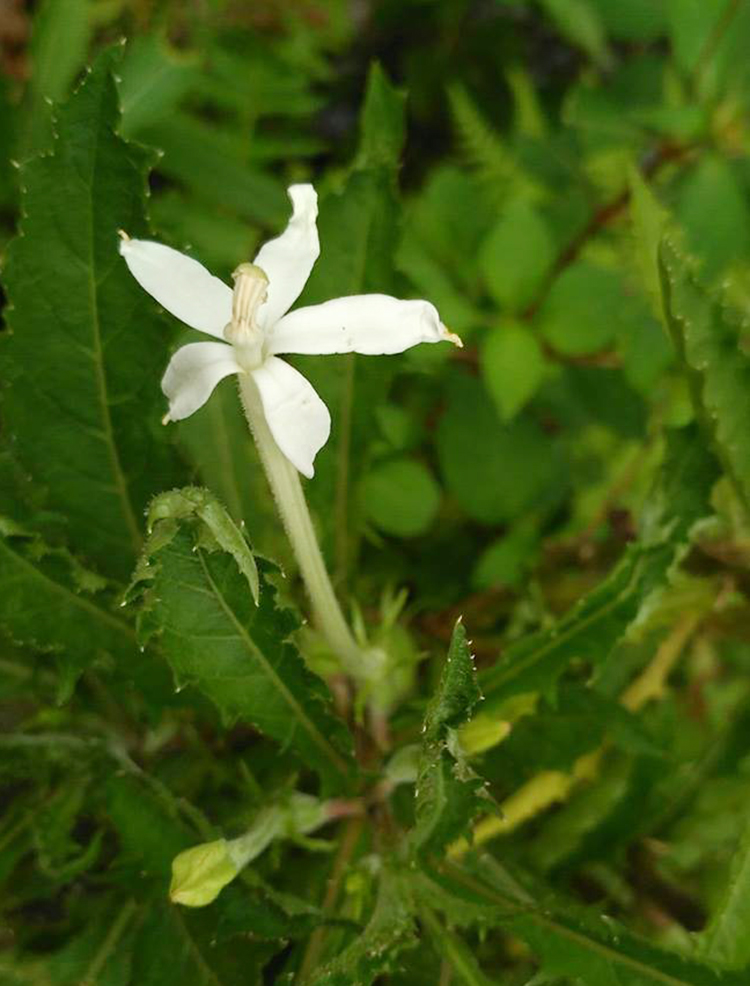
[240,374,367,679]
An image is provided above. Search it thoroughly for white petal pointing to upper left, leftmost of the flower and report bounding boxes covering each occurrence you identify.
[120,237,232,339]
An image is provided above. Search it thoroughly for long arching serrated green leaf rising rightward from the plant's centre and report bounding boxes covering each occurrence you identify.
[481,428,717,712]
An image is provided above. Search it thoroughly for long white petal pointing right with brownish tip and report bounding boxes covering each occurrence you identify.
[267,294,461,356]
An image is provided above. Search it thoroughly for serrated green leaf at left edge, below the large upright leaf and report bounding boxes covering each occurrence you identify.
[0,518,137,701]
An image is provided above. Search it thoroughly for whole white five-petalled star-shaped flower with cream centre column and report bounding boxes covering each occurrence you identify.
[120,185,461,477]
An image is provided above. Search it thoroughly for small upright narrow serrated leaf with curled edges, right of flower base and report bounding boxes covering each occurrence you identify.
[411,622,487,853]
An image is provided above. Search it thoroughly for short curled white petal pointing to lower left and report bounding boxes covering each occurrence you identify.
[161,342,243,421]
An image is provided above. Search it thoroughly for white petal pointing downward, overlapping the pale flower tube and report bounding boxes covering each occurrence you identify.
[253,356,331,479]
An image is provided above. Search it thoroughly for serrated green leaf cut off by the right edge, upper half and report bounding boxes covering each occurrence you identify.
[659,239,750,502]
